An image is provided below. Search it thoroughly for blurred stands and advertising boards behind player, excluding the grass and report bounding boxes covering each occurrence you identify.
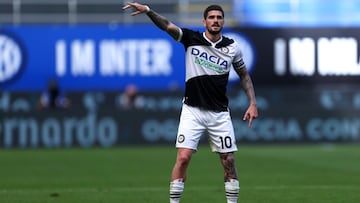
[0,0,360,148]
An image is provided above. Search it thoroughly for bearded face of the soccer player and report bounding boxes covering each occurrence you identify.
[203,10,224,35]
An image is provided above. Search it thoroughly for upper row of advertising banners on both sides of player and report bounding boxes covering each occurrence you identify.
[0,24,360,92]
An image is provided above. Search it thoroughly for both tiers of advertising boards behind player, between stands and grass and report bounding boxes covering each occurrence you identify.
[0,25,360,148]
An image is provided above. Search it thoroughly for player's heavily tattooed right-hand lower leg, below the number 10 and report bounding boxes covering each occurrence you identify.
[220,152,240,203]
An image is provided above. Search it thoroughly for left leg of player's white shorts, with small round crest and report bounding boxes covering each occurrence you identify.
[176,104,206,150]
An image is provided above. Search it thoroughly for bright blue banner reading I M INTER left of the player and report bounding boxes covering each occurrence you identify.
[0,25,185,91]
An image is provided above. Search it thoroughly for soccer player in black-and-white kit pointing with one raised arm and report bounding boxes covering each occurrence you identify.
[123,2,258,203]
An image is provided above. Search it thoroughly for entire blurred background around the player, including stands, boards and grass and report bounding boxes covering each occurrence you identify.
[0,0,360,203]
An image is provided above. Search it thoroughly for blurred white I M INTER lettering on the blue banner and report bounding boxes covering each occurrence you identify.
[56,39,172,77]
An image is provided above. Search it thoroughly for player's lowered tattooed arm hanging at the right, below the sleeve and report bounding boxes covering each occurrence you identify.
[235,67,258,127]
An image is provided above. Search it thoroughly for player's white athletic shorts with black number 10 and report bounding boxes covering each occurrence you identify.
[176,104,237,153]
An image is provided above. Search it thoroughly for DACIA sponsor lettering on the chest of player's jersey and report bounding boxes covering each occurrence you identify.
[191,48,228,73]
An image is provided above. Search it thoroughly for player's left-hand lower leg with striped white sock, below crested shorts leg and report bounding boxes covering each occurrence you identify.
[170,148,193,203]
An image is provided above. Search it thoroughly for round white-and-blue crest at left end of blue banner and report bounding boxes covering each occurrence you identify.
[0,31,25,85]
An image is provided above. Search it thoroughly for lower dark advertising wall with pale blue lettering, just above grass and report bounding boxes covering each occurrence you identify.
[0,87,360,148]
